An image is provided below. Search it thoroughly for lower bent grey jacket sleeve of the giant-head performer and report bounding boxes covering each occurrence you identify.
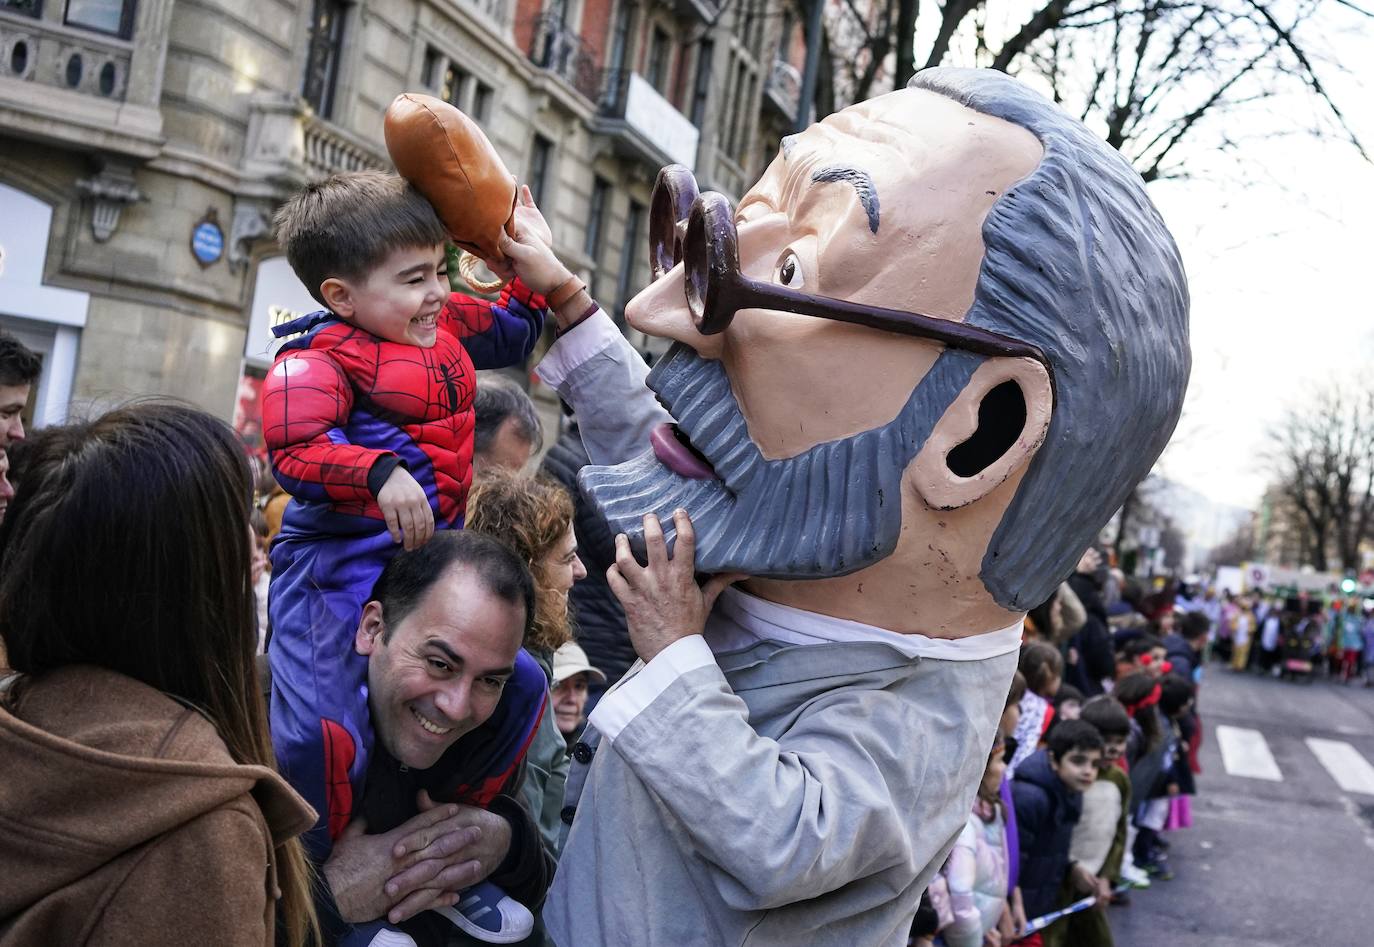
[610,665,923,911]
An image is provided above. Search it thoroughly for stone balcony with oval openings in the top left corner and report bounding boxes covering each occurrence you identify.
[0,9,162,159]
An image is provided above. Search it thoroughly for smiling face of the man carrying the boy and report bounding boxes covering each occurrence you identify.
[356,566,525,770]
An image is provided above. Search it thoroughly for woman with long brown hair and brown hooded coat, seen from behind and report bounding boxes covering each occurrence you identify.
[0,403,319,947]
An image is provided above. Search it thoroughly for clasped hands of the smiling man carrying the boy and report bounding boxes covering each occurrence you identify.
[322,805,481,924]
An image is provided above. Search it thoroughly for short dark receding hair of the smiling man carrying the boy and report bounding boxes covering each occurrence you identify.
[368,529,534,642]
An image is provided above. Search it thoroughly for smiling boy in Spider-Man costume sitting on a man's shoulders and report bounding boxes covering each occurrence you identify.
[262,172,568,939]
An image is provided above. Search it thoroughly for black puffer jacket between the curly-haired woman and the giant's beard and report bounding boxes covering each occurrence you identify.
[543,426,636,687]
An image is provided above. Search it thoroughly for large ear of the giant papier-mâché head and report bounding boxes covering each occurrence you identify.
[907,359,1054,510]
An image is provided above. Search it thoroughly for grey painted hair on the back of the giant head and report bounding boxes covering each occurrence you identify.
[910,69,1191,612]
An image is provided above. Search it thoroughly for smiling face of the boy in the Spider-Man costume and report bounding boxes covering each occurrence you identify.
[320,243,449,349]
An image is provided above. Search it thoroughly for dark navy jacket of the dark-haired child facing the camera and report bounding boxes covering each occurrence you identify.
[1011,749,1083,918]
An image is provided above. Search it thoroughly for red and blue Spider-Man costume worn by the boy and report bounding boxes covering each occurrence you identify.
[262,280,547,862]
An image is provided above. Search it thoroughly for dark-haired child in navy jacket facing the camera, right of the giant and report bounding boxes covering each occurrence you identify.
[1011,720,1106,947]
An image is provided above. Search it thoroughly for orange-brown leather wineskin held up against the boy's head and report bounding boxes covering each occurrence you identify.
[385,92,515,260]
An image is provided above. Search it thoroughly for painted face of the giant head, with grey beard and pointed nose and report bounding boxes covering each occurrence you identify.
[584,89,1041,577]
